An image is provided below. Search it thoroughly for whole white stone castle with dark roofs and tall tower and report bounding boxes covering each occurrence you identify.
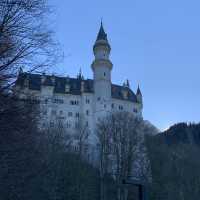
[15,23,143,140]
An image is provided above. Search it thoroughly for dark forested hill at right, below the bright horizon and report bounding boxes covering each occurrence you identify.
[158,123,200,146]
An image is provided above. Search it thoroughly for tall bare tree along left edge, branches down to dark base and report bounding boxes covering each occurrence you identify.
[0,0,61,196]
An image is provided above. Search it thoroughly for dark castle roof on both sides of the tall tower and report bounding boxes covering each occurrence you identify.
[16,73,137,102]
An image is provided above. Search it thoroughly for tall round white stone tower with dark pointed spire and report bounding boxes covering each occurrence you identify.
[91,22,113,120]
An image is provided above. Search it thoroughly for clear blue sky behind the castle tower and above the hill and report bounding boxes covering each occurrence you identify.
[50,0,200,130]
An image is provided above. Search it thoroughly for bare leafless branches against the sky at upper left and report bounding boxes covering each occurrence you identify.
[0,0,58,90]
